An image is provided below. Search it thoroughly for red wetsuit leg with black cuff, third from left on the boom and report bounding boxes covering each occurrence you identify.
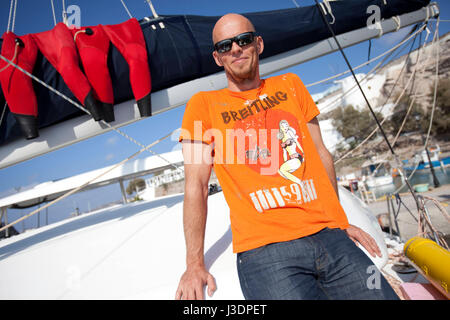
[71,26,115,122]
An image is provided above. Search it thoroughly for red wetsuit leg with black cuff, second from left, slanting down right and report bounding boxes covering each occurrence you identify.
[33,22,103,121]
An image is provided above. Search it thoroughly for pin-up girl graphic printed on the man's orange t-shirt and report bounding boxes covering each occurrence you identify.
[277,120,304,184]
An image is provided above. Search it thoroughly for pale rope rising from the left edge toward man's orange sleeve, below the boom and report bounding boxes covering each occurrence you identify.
[0,130,175,232]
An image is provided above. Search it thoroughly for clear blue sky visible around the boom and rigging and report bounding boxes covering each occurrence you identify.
[0,0,450,230]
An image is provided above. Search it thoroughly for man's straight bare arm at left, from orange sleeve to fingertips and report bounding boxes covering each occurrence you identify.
[175,142,216,300]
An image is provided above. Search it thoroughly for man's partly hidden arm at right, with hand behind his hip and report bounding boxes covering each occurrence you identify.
[307,118,381,257]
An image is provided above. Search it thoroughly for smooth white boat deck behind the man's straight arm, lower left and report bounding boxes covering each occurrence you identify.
[0,193,243,299]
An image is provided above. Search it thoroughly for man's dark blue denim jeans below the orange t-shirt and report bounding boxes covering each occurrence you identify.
[237,228,399,300]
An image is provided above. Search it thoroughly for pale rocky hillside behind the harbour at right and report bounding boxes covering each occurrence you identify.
[313,33,450,162]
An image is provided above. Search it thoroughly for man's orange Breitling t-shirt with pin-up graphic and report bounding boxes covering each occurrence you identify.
[180,73,348,252]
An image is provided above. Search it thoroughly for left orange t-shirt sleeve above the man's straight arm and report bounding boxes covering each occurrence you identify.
[178,92,213,144]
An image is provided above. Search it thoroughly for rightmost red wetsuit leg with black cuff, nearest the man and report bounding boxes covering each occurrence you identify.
[102,18,151,117]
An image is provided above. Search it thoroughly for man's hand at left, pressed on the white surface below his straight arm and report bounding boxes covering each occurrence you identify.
[175,266,216,300]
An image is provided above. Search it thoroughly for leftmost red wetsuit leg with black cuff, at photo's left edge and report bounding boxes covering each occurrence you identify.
[0,32,39,139]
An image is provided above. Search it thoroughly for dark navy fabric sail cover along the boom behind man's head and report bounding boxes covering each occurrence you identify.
[0,0,430,145]
